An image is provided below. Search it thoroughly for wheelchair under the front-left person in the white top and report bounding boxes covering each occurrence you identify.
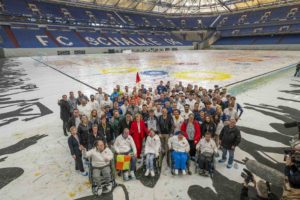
[89,159,118,196]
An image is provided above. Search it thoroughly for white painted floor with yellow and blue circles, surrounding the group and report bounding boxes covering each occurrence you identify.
[0,50,300,200]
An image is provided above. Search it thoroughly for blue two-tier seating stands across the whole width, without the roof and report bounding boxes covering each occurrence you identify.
[0,0,300,53]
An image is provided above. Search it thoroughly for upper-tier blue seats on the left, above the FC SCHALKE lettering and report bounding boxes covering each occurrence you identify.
[0,0,211,29]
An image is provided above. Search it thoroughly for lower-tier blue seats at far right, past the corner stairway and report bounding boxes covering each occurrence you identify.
[213,34,300,45]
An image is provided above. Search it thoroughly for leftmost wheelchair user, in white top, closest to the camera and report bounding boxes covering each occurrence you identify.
[82,140,113,193]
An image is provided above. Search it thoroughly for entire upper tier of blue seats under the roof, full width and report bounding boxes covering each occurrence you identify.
[0,0,300,29]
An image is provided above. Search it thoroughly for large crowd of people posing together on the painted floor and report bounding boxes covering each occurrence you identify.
[58,81,243,180]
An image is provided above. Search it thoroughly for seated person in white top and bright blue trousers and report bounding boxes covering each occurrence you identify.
[168,131,190,175]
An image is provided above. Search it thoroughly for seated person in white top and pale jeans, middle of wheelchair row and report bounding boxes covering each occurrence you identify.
[145,129,161,177]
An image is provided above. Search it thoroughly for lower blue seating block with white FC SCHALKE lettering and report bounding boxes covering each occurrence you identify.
[0,26,192,48]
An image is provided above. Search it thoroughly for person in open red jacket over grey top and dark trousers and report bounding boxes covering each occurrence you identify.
[181,113,201,157]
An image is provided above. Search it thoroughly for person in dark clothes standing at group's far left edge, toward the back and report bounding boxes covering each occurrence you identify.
[58,95,71,136]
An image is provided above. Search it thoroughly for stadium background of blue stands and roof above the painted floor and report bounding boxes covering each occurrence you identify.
[0,0,300,56]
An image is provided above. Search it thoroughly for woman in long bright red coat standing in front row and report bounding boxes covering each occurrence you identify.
[130,114,148,158]
